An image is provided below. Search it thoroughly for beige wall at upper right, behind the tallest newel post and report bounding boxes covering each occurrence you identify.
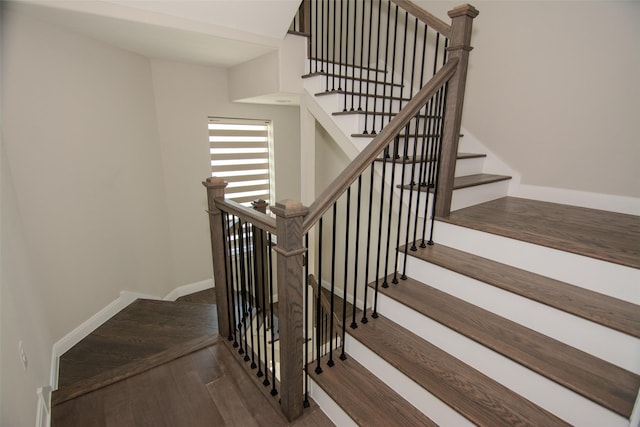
[418,0,640,197]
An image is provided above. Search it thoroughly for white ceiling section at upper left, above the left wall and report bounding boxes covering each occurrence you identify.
[3,0,300,67]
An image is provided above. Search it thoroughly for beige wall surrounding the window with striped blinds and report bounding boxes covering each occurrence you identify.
[152,60,300,283]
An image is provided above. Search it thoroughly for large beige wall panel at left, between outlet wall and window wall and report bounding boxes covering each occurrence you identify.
[2,12,174,339]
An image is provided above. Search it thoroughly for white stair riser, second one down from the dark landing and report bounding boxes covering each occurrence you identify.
[406,254,640,373]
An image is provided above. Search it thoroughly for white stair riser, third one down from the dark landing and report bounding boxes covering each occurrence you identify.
[374,294,627,427]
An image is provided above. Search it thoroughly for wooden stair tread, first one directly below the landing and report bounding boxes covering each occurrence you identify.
[409,244,640,338]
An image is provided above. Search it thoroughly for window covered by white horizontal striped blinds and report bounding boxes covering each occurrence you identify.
[209,117,273,206]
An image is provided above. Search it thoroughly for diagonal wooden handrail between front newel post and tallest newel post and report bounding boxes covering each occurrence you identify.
[302,59,458,233]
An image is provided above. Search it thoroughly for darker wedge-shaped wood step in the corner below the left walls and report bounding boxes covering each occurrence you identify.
[52,299,217,405]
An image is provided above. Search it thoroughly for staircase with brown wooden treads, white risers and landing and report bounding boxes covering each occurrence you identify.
[286,1,640,426]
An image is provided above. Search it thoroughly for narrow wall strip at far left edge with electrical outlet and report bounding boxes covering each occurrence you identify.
[0,136,53,427]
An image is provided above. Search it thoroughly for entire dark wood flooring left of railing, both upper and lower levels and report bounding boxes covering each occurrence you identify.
[52,289,333,427]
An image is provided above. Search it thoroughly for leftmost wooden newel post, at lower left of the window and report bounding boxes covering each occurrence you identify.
[202,177,233,338]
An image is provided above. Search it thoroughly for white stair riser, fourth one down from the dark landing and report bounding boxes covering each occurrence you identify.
[345,336,473,427]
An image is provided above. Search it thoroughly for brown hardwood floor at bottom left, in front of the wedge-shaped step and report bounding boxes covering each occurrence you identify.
[52,342,333,427]
